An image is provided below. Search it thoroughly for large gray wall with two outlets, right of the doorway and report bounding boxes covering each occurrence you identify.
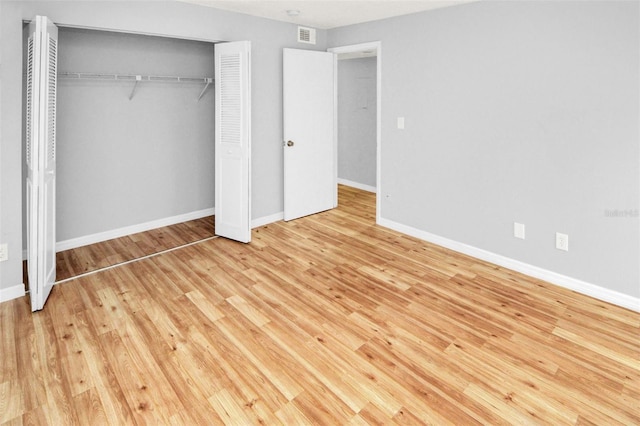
[328,1,640,297]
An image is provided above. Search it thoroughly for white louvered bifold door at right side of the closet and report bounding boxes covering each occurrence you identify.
[215,41,251,243]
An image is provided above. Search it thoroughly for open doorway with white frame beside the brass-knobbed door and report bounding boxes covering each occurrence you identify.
[328,42,382,222]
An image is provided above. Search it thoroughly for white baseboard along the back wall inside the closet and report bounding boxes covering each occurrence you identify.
[56,208,215,252]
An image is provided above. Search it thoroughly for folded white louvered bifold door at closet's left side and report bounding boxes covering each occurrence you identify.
[26,16,58,311]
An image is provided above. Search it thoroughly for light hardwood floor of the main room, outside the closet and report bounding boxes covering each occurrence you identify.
[0,187,640,425]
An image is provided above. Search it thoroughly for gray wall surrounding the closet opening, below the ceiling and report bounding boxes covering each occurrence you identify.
[0,1,326,296]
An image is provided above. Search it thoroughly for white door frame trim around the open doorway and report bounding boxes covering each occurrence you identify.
[327,41,382,224]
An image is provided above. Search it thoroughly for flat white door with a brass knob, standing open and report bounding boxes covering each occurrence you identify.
[283,49,338,220]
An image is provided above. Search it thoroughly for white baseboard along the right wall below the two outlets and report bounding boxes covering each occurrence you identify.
[378,218,640,312]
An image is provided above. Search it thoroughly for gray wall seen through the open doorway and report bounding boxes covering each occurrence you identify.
[338,58,377,187]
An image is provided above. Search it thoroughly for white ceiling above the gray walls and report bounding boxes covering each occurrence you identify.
[181,0,477,29]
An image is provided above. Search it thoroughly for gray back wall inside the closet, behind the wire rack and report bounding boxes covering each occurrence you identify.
[23,27,215,247]
